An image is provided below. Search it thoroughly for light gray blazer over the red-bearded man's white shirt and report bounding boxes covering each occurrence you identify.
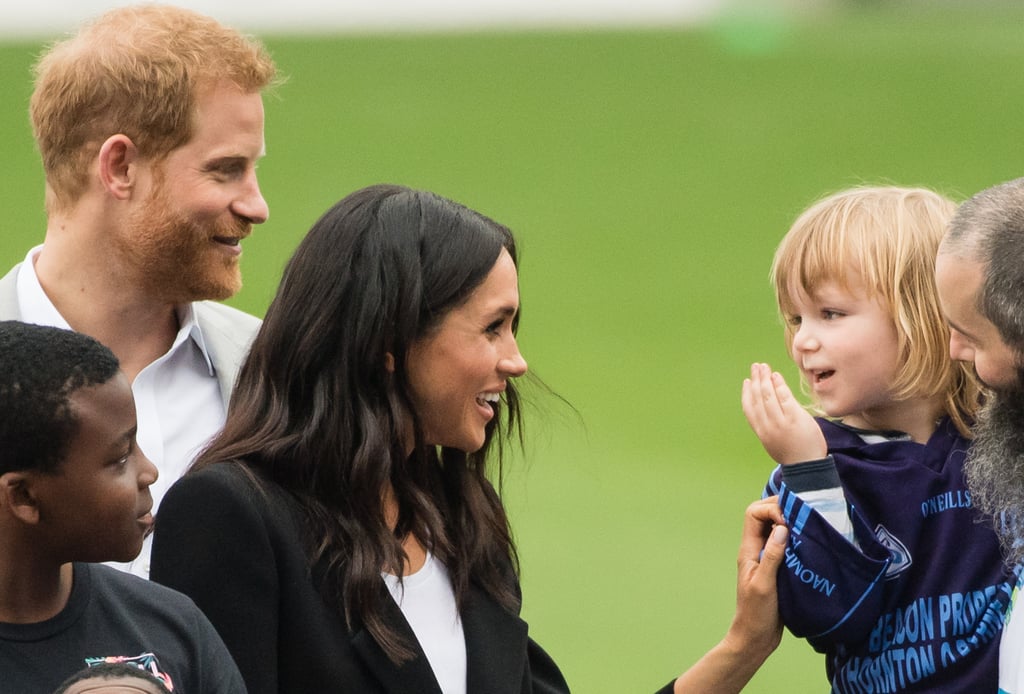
[0,263,261,407]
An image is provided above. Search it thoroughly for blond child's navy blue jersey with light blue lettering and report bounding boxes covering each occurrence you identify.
[767,419,1016,694]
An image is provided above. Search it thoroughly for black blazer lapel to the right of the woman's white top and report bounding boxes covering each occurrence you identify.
[462,585,527,694]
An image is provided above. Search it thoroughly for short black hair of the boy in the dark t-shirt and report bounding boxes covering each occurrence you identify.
[0,320,120,475]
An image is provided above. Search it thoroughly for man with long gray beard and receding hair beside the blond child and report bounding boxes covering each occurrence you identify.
[935,178,1024,694]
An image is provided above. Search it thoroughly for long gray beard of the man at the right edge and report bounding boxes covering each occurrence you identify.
[964,382,1024,565]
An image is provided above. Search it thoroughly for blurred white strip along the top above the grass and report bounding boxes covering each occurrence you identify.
[0,0,730,37]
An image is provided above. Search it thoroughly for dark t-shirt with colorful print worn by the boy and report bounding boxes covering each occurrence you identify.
[0,563,246,694]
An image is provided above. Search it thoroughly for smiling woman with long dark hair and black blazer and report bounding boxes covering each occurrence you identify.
[152,185,781,694]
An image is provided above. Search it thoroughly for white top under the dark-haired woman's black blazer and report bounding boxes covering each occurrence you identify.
[381,552,466,694]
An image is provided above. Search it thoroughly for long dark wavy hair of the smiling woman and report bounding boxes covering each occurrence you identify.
[193,185,521,663]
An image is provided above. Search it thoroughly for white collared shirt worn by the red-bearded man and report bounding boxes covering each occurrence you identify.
[17,246,225,578]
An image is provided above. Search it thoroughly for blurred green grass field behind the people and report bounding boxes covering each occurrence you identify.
[0,3,1024,694]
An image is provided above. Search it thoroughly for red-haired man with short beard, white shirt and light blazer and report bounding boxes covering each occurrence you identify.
[0,5,275,576]
